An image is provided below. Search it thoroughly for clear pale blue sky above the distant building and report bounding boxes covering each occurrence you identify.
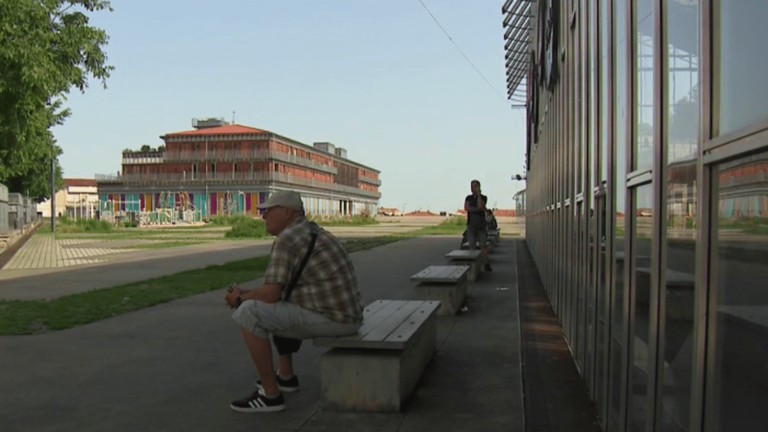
[53,0,525,212]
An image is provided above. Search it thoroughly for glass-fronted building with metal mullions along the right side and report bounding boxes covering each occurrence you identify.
[510,0,768,432]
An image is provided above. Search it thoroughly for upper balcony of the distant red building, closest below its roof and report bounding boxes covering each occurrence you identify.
[164,149,339,174]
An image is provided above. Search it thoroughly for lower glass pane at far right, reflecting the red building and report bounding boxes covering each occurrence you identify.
[708,152,768,431]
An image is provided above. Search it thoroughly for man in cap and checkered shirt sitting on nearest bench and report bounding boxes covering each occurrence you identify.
[224,191,363,413]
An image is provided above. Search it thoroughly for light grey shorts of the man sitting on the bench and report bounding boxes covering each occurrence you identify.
[232,300,362,339]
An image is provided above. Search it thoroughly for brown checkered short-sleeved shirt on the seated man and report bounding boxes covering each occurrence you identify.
[264,217,363,324]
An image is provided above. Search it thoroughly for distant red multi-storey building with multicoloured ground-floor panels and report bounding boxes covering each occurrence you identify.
[96,118,381,221]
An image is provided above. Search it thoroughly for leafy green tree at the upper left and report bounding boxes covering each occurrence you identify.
[0,0,113,200]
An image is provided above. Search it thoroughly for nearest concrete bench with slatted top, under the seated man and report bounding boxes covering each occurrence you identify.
[314,300,440,412]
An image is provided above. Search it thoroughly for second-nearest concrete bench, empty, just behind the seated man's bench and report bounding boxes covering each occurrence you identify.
[411,266,469,316]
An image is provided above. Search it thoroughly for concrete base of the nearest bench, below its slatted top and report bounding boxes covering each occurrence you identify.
[320,314,437,412]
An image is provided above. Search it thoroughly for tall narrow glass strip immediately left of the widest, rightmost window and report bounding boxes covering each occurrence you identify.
[659,1,699,432]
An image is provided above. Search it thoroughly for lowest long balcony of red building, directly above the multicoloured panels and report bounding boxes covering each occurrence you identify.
[95,171,381,199]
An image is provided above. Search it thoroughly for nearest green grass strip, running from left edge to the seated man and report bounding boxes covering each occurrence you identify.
[0,256,269,335]
